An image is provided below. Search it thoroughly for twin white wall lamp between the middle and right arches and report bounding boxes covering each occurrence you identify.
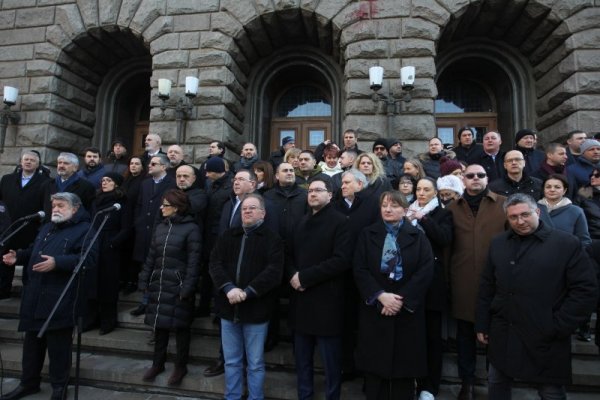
[369,66,415,137]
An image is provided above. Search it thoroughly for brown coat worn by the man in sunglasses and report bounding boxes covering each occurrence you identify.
[448,192,506,322]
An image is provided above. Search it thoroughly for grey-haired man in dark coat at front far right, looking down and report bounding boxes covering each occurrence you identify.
[476,194,598,400]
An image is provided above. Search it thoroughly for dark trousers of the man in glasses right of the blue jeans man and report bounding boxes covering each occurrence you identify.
[294,333,342,400]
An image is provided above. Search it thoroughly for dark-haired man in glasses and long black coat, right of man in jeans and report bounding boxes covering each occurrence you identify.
[287,178,351,400]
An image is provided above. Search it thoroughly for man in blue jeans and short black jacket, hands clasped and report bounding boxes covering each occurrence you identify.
[210,194,283,399]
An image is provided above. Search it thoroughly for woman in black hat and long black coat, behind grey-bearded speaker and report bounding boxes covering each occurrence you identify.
[91,172,126,335]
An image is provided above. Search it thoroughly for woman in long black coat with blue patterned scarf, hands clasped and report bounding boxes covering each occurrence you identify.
[354,192,434,400]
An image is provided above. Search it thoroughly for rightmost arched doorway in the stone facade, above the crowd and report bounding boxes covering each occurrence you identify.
[435,38,535,148]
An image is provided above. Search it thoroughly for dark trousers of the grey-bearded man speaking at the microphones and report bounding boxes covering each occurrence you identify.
[21,328,73,390]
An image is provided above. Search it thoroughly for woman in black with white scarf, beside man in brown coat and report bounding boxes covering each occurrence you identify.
[407,177,452,399]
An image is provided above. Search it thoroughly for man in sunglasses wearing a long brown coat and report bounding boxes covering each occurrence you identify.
[449,164,506,400]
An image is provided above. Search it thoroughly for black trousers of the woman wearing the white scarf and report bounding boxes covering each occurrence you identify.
[417,310,444,396]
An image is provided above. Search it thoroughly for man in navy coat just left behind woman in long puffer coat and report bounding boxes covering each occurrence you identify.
[130,154,177,316]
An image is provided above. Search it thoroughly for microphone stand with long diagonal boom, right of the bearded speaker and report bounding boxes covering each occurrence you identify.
[37,214,110,400]
